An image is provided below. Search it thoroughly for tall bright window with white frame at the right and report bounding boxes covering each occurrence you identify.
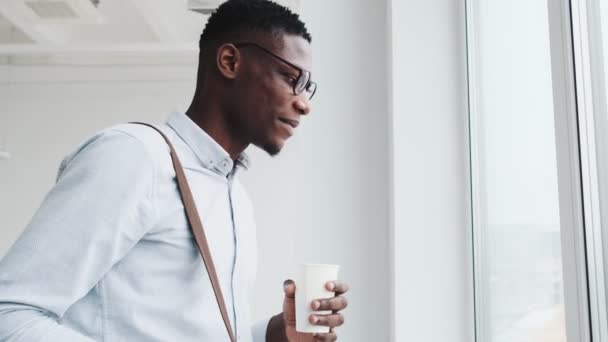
[467,0,608,342]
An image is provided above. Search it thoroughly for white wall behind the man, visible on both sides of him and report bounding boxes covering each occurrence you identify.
[0,0,390,341]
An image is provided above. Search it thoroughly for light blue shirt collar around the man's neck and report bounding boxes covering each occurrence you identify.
[167,112,249,176]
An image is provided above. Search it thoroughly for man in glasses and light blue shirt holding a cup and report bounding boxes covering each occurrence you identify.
[0,0,348,342]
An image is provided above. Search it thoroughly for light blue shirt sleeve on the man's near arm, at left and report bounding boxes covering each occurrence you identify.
[0,131,155,342]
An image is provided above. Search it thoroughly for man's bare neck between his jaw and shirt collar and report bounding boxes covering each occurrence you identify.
[186,98,249,160]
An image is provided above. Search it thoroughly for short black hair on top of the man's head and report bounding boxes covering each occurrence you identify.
[199,0,312,52]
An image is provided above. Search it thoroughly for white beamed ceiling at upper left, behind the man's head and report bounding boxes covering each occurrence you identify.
[0,0,211,45]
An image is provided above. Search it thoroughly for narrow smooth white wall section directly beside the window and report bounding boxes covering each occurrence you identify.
[389,0,474,342]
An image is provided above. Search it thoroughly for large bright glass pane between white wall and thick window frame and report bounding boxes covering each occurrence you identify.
[471,0,566,342]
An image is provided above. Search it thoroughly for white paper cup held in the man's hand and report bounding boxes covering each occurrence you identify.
[295,264,340,333]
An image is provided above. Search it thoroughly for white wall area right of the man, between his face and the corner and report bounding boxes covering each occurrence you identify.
[246,0,390,341]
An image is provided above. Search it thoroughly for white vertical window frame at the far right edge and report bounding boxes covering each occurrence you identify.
[561,0,608,342]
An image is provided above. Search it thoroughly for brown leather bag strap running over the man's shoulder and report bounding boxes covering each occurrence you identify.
[131,122,236,342]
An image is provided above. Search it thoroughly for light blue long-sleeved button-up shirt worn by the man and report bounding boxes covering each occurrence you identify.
[0,113,268,342]
